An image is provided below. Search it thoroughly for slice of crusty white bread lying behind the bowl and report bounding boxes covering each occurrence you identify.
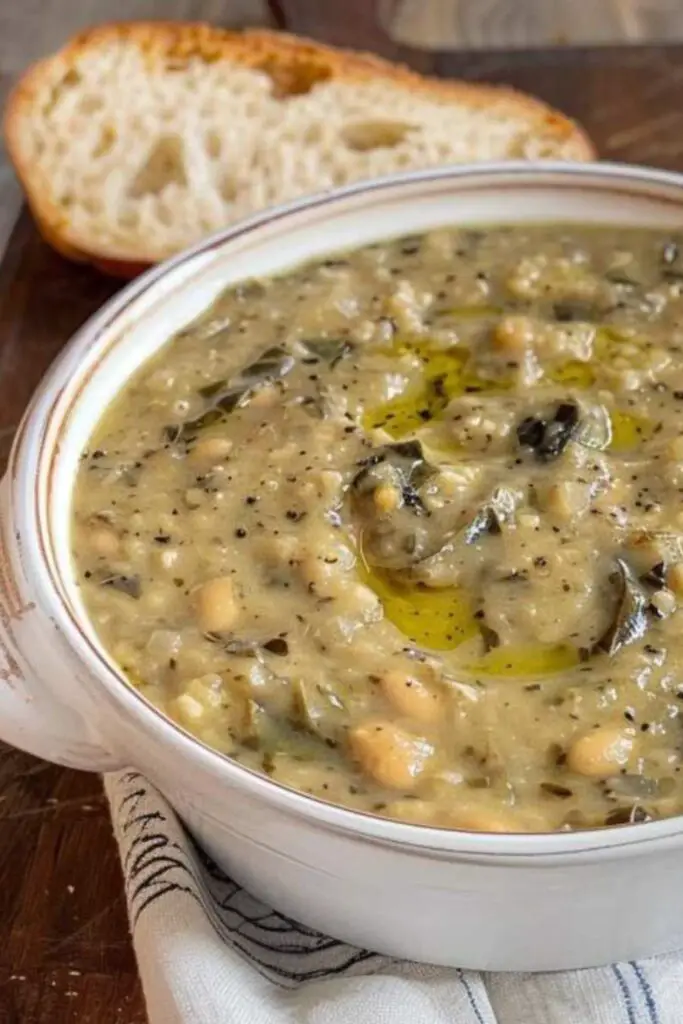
[5,22,594,274]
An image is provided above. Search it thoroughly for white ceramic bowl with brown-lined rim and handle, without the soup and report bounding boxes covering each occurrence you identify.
[0,164,683,971]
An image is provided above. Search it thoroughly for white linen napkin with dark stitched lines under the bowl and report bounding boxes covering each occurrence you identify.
[104,771,683,1024]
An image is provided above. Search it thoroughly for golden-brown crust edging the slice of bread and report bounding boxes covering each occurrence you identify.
[4,22,596,278]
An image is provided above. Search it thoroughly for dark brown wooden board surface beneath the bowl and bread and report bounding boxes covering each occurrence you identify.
[0,0,683,1024]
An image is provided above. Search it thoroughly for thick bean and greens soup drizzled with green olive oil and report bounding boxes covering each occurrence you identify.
[73,224,683,831]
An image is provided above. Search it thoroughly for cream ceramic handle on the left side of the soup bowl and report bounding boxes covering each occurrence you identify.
[0,480,124,771]
